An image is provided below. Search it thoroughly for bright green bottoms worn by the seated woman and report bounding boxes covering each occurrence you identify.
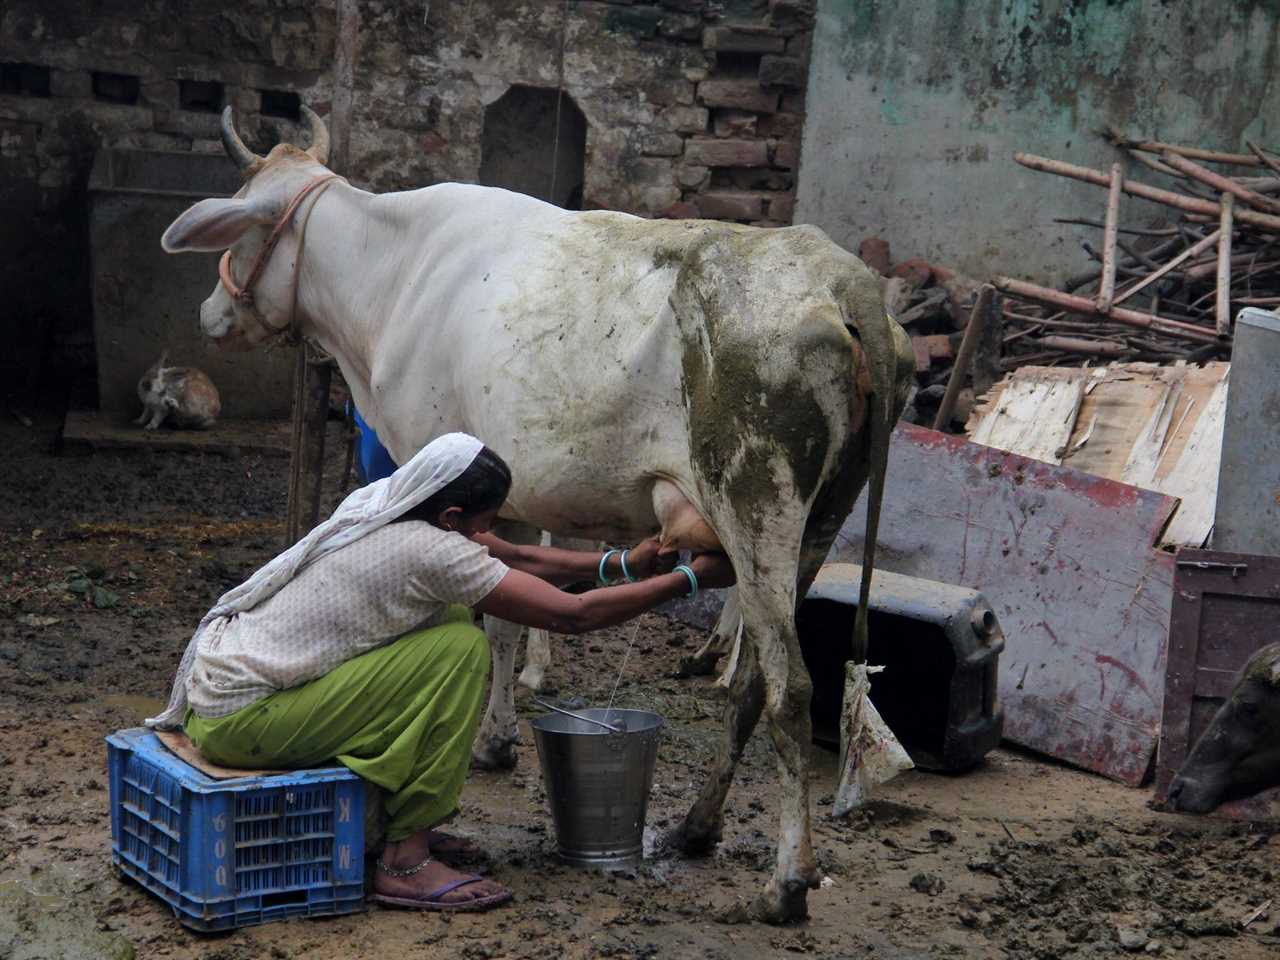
[184,607,489,841]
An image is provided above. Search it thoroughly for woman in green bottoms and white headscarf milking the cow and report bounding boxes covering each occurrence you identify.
[147,434,733,910]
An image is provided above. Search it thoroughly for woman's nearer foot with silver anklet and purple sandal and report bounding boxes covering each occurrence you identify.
[372,831,512,911]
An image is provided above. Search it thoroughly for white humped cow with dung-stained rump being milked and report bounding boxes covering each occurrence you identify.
[163,110,913,922]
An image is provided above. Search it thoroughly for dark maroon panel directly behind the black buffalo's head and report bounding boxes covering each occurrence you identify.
[1156,550,1280,819]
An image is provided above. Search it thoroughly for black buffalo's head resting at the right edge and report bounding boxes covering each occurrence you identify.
[1169,644,1280,813]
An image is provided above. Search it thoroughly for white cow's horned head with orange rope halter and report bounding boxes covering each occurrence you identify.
[160,105,329,349]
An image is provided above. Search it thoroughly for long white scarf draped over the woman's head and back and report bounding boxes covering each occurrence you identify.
[146,434,484,730]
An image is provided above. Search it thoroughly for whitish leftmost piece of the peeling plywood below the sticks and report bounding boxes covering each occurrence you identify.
[972,370,1084,463]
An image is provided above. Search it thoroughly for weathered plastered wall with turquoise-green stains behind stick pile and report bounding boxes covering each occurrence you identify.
[796,0,1280,280]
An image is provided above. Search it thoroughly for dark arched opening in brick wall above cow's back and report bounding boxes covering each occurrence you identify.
[480,87,586,210]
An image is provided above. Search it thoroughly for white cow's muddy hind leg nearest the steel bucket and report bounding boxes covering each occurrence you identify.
[667,634,764,856]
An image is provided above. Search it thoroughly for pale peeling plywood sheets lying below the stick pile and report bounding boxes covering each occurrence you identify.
[968,362,1230,547]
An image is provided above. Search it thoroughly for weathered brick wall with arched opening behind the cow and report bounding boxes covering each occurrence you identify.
[0,0,814,391]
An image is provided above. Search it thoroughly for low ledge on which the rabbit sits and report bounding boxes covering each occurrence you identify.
[63,411,289,457]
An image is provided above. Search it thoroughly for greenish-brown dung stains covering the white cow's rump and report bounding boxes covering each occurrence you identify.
[672,227,900,542]
